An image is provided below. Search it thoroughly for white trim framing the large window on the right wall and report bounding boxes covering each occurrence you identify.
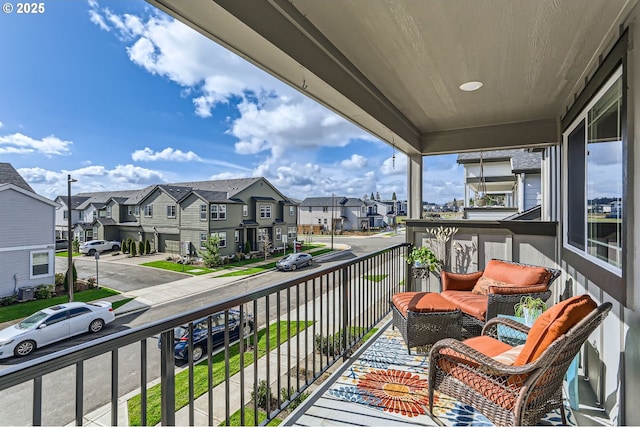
[562,67,624,277]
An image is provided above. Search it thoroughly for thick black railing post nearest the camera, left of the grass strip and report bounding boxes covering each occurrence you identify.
[160,329,176,426]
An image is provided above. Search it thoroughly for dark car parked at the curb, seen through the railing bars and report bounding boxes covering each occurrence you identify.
[158,310,253,362]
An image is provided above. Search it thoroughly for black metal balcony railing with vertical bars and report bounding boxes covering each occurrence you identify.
[0,244,407,425]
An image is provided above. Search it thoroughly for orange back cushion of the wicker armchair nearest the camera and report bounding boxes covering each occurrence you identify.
[514,295,597,366]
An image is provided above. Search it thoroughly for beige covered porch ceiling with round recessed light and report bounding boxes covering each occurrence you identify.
[147,0,637,155]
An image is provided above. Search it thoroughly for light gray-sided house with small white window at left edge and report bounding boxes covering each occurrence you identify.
[0,163,57,297]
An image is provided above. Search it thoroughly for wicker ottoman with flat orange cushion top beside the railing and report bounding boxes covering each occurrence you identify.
[391,292,462,354]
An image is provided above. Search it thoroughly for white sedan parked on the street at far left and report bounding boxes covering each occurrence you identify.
[0,301,115,359]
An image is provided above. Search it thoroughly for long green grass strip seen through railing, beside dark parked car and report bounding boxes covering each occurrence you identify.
[127,321,313,426]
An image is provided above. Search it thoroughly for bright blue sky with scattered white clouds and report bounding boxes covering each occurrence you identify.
[0,0,464,202]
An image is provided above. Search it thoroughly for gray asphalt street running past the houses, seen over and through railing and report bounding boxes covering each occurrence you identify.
[0,235,404,425]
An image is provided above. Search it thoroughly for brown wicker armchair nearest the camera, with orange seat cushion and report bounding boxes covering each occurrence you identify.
[429,303,612,425]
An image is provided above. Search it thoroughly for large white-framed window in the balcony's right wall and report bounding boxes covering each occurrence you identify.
[564,69,626,274]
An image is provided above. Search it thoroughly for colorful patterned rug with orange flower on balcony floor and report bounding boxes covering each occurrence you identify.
[316,328,575,426]
